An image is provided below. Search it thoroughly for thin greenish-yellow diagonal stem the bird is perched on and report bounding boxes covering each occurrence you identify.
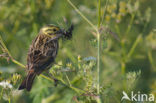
[0,36,85,93]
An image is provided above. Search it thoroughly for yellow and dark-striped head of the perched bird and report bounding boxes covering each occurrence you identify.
[40,24,64,39]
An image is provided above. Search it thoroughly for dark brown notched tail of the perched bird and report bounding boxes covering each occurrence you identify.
[18,72,36,91]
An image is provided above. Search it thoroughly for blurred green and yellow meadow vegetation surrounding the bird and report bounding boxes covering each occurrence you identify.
[0,0,156,103]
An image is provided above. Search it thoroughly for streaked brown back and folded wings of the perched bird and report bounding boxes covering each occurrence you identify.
[27,34,58,74]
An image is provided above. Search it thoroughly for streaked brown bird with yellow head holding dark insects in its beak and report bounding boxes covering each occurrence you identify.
[18,24,73,91]
